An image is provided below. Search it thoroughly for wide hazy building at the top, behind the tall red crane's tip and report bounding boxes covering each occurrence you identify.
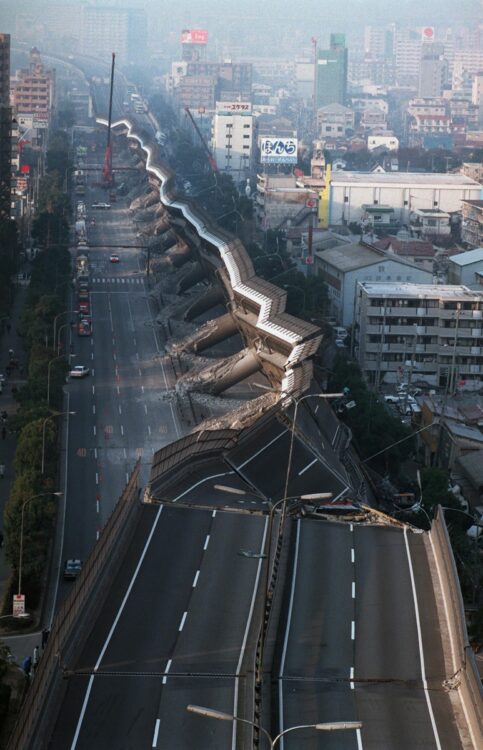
[81,5,147,63]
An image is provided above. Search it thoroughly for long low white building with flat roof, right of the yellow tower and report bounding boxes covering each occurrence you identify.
[325,171,481,225]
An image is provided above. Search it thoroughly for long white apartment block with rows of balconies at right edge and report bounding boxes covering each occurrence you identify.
[355,282,483,390]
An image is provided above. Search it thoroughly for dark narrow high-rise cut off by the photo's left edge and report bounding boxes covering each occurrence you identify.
[0,33,12,217]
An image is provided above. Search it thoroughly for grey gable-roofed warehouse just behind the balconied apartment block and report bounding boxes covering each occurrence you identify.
[314,242,433,326]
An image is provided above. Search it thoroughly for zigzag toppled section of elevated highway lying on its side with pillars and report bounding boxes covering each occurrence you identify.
[97,118,321,414]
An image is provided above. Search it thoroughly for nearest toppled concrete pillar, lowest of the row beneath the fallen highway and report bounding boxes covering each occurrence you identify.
[176,349,260,395]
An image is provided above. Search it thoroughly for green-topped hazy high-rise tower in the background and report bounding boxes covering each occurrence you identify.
[316,34,348,109]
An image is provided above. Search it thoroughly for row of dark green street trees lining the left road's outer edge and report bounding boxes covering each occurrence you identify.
[3,131,71,608]
